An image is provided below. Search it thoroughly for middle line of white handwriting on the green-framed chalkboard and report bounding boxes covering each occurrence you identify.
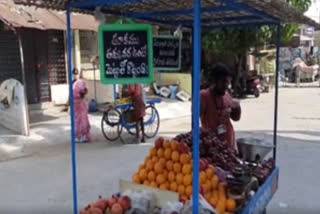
[106,45,147,60]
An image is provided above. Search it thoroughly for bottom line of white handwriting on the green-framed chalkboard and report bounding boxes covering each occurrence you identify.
[106,59,148,78]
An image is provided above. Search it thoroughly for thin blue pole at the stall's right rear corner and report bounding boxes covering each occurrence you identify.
[273,24,281,161]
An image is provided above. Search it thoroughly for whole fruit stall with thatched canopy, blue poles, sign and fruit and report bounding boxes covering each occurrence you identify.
[15,0,320,214]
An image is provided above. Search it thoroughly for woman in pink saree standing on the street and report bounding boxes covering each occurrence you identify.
[73,77,91,143]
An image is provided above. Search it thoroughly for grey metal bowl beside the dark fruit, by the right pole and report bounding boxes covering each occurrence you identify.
[237,138,274,163]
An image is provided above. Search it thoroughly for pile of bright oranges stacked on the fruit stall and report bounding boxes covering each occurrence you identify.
[132,140,236,214]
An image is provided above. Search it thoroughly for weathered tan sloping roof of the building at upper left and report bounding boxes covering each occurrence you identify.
[0,0,98,31]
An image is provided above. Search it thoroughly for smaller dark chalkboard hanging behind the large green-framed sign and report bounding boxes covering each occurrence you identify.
[153,36,181,71]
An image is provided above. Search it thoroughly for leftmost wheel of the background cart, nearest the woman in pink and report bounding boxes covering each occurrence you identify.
[101,108,122,141]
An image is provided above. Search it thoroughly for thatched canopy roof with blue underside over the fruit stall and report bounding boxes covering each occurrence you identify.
[15,0,320,28]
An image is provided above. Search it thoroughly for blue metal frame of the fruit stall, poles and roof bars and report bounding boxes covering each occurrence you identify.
[66,0,280,214]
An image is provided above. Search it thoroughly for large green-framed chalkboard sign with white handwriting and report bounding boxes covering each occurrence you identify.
[98,20,154,84]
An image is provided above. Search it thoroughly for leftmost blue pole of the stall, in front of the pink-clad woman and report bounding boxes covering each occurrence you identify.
[66,6,78,214]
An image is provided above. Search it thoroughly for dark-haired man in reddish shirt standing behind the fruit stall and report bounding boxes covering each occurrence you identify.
[200,64,241,150]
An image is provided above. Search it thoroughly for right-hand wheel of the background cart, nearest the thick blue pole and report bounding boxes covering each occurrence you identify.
[143,106,160,138]
